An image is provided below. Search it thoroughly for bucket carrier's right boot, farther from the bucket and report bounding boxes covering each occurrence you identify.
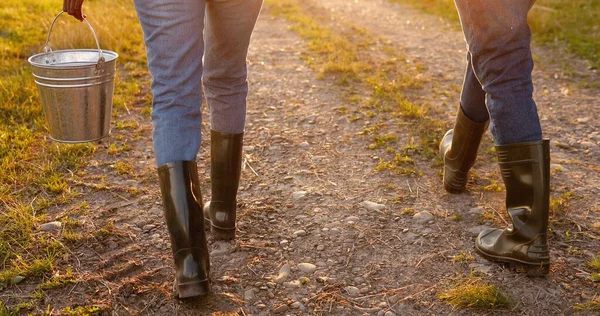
[204,130,244,239]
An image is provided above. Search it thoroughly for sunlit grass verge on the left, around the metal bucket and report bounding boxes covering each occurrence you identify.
[0,0,147,308]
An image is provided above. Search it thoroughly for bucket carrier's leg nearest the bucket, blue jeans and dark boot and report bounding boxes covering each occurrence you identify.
[135,0,210,298]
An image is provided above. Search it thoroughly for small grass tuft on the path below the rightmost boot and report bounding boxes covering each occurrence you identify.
[439,276,511,309]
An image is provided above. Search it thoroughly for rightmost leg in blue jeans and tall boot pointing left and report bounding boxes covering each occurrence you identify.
[455,0,550,275]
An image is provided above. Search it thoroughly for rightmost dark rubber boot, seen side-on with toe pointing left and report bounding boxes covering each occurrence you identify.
[475,140,550,276]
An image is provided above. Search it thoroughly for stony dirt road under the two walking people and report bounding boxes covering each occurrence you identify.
[3,0,600,316]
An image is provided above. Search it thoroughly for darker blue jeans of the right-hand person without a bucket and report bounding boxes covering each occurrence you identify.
[454,0,542,145]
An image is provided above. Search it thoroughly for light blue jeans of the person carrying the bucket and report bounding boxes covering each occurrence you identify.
[134,0,262,166]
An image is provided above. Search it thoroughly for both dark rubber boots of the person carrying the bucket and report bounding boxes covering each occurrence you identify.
[158,131,243,298]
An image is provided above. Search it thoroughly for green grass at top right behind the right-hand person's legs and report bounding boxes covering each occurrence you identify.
[390,0,600,67]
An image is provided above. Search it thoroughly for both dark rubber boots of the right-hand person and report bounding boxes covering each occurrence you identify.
[440,108,550,276]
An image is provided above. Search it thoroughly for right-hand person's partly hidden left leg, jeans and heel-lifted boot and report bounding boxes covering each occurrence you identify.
[440,53,489,193]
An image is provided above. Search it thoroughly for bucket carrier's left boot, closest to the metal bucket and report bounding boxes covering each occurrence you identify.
[158,161,210,298]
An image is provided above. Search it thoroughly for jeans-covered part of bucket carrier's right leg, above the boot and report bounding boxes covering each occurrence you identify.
[202,0,262,134]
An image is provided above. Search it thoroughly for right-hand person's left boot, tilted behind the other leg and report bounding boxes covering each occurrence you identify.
[440,107,489,193]
